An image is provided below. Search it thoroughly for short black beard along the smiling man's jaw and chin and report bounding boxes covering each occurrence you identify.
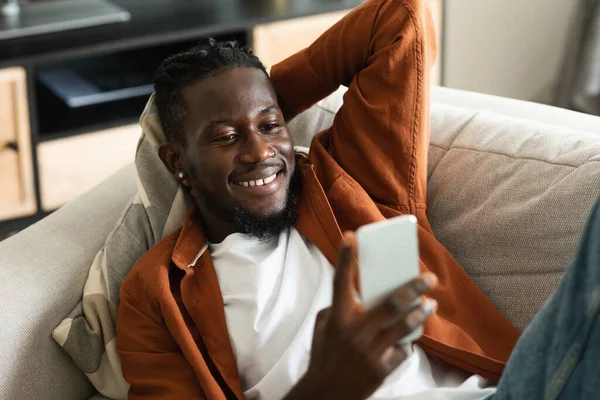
[188,167,302,240]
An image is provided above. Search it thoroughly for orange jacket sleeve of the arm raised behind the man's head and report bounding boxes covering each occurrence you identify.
[271,0,436,209]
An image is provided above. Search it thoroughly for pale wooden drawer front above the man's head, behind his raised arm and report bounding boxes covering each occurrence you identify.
[253,10,349,70]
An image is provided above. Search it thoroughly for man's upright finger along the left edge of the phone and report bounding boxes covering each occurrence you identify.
[331,232,356,318]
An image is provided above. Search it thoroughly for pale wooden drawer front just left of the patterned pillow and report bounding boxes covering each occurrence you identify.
[38,124,141,211]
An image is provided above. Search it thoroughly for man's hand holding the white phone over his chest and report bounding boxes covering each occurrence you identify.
[298,232,437,399]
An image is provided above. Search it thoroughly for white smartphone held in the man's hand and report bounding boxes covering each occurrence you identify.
[356,215,423,343]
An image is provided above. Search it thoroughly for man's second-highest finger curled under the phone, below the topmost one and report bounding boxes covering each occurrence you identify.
[374,299,437,354]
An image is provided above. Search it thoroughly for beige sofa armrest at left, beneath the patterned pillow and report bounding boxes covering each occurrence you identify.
[0,165,136,400]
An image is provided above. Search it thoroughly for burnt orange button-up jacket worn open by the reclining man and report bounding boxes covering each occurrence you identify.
[117,0,518,400]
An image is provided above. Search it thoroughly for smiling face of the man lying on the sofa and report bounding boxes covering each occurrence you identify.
[165,68,295,239]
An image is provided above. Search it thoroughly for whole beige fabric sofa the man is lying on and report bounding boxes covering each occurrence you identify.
[0,88,600,400]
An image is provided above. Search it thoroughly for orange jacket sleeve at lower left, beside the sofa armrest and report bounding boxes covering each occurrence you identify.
[117,289,205,400]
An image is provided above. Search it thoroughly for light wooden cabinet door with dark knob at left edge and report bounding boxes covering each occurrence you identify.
[0,67,36,220]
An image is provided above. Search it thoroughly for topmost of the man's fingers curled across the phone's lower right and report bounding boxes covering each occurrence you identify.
[358,272,437,336]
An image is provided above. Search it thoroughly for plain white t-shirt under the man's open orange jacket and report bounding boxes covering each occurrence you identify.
[210,228,495,400]
